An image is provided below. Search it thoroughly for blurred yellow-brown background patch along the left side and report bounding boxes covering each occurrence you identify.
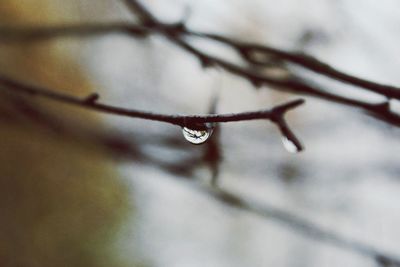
[0,0,132,267]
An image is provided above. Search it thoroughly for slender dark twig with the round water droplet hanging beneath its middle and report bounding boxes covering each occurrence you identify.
[0,75,304,132]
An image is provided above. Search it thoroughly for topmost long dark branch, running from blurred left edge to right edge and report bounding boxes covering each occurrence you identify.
[0,22,400,102]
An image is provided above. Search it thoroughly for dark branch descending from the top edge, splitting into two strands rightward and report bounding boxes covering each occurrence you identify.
[112,0,400,126]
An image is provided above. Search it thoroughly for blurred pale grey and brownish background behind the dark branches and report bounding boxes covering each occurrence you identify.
[0,0,400,267]
